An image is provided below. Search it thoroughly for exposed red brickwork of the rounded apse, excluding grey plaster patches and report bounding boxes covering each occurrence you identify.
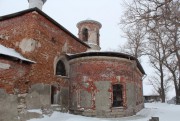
[70,57,142,110]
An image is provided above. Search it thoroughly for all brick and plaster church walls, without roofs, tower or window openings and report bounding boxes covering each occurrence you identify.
[0,10,143,117]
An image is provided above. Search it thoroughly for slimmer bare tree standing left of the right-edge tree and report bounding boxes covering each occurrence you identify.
[146,25,167,102]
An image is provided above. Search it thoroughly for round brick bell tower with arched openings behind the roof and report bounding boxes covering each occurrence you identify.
[77,20,102,51]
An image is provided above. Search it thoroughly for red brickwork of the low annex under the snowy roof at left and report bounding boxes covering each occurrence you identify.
[0,57,31,93]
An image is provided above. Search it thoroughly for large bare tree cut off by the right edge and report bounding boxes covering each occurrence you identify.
[163,0,180,104]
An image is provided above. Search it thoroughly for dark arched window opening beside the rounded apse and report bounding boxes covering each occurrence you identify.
[56,61,66,76]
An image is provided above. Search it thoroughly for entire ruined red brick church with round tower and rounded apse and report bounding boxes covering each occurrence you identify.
[0,0,145,120]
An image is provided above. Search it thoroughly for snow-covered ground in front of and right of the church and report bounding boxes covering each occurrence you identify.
[29,103,180,121]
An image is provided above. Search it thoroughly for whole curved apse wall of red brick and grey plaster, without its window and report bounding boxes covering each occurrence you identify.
[70,56,143,117]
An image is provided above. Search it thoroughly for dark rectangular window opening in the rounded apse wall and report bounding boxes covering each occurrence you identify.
[112,84,123,107]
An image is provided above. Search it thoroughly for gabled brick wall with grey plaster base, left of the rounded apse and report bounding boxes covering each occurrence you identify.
[0,11,87,114]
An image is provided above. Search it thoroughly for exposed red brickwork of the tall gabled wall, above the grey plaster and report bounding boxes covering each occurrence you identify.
[0,11,87,93]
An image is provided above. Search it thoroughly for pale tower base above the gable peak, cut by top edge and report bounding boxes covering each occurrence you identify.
[28,0,46,10]
